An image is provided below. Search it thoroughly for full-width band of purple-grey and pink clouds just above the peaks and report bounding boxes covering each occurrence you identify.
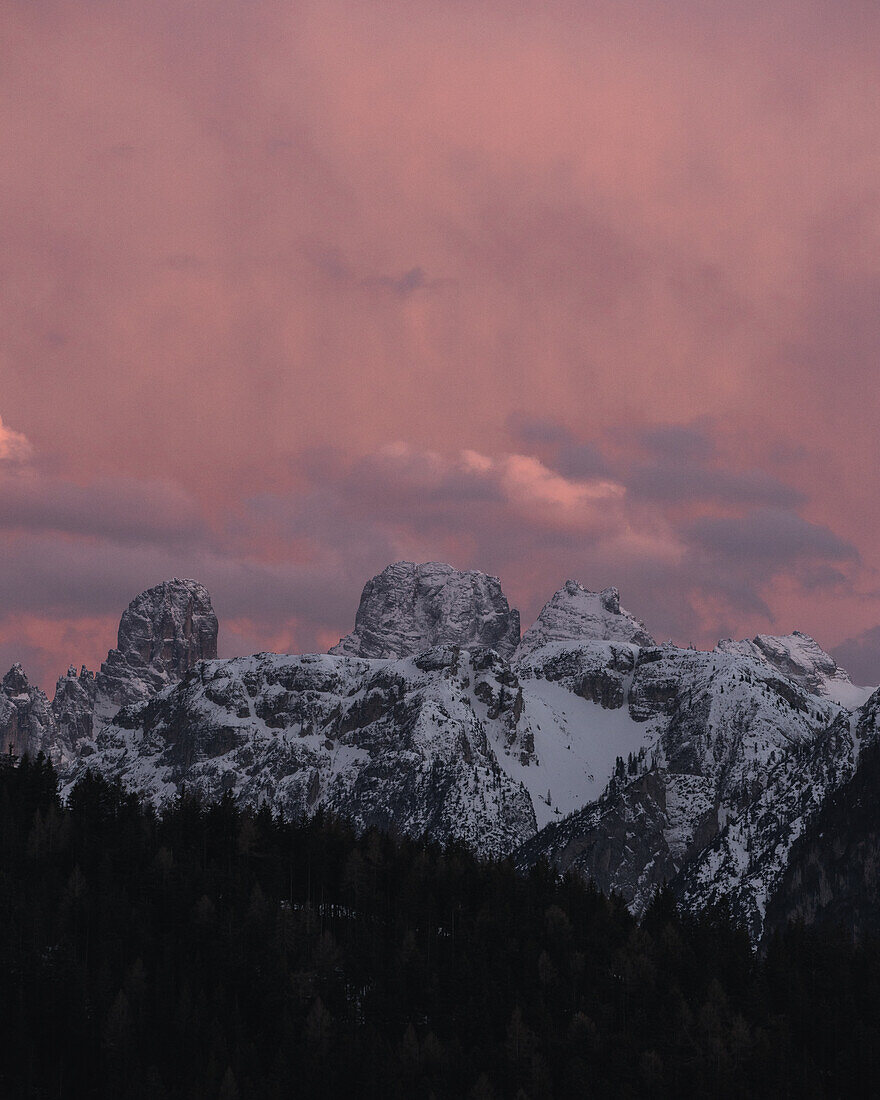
[0,435,858,679]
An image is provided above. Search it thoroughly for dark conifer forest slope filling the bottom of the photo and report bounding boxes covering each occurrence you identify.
[0,759,880,1100]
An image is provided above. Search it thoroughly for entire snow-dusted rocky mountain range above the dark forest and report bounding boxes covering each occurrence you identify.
[0,562,877,937]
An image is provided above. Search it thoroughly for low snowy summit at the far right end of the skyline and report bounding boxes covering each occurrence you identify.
[715,630,869,706]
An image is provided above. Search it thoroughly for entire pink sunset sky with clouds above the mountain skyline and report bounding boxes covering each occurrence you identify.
[0,0,880,688]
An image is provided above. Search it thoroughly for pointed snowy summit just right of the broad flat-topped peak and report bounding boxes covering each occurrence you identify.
[516,581,656,660]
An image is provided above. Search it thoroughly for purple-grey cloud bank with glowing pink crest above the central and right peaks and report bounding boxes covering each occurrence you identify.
[272,440,859,641]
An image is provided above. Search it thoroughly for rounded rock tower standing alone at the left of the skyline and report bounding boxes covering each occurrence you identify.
[96,579,217,715]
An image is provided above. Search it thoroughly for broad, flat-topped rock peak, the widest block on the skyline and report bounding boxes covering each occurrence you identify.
[330,561,519,658]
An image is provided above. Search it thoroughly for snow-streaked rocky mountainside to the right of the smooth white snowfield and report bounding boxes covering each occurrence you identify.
[518,647,849,936]
